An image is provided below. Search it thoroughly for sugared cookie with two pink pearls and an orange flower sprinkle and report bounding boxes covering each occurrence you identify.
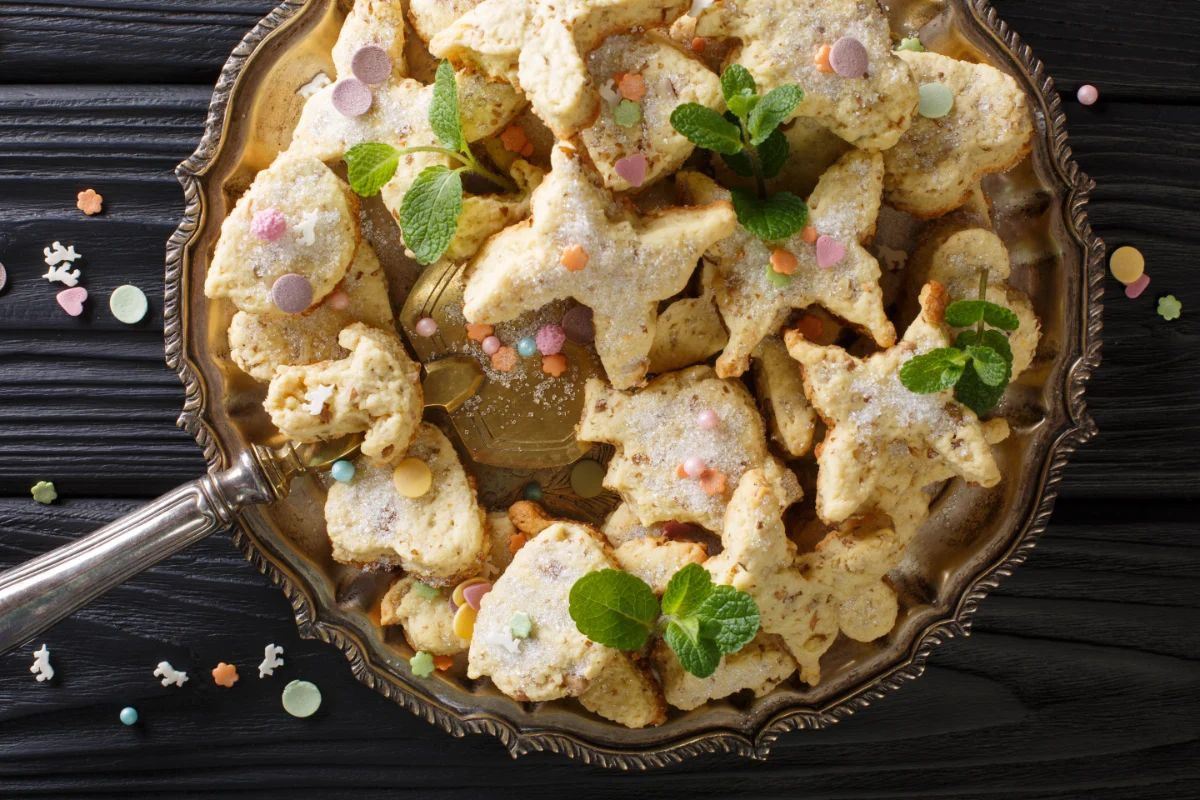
[578,367,800,533]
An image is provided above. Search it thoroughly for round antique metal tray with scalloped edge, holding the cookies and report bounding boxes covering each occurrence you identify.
[164,0,1104,769]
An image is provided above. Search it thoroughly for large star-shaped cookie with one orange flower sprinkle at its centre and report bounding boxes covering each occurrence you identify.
[463,145,737,389]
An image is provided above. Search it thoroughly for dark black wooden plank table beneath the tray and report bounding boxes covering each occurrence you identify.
[0,0,1200,800]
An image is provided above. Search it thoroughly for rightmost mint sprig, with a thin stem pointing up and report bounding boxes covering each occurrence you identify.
[900,270,1020,415]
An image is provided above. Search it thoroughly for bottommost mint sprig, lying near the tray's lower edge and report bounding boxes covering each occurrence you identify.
[569,564,760,678]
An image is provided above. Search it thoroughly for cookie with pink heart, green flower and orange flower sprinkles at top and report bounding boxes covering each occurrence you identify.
[580,31,725,192]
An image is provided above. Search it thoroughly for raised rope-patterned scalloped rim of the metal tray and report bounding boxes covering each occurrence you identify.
[163,0,1105,770]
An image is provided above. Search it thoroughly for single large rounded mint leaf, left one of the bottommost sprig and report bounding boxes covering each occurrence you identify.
[569,570,659,650]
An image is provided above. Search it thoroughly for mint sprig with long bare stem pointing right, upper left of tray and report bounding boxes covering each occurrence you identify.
[343,61,517,264]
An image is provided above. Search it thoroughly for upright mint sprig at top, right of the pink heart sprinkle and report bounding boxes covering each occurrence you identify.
[671,64,808,240]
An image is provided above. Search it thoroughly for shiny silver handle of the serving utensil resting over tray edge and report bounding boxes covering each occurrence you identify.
[0,451,278,652]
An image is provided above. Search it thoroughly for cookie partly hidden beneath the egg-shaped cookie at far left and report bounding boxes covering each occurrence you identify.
[229,241,394,383]
